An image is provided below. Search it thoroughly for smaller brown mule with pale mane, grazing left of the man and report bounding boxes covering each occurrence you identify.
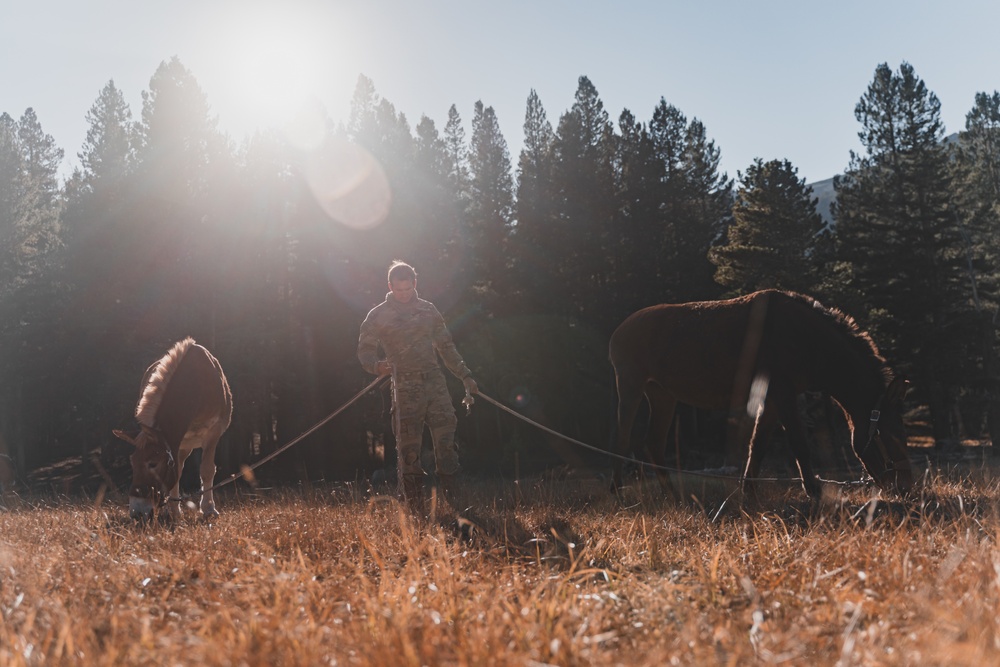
[114,338,233,519]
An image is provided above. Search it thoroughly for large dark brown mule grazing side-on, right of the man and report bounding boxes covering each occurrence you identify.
[610,290,913,498]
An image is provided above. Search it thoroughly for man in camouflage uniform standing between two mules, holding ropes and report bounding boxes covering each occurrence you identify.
[358,260,479,516]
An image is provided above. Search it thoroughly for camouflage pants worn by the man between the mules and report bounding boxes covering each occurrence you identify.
[392,370,459,480]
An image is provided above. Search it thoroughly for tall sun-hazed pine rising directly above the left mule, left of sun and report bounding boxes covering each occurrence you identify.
[120,57,235,355]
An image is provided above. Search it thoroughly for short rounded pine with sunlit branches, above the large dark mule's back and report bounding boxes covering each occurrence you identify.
[709,158,823,295]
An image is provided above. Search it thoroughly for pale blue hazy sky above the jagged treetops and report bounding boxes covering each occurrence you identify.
[0,0,1000,183]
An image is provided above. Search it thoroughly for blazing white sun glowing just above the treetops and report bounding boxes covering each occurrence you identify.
[216,3,340,147]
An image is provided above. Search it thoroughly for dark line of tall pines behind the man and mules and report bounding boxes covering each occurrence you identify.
[0,59,1000,480]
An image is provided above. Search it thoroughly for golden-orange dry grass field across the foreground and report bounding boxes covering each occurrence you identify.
[0,466,1000,666]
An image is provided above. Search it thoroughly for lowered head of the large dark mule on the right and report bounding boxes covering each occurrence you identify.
[854,378,913,493]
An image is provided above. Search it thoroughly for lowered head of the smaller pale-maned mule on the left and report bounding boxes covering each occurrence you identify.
[114,426,180,520]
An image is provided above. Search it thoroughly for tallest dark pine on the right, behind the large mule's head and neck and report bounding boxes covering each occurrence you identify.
[834,63,969,440]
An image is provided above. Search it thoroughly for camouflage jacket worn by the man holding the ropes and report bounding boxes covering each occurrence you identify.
[358,292,472,380]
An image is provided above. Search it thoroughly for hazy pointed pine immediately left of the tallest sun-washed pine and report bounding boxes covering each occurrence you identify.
[51,81,148,480]
